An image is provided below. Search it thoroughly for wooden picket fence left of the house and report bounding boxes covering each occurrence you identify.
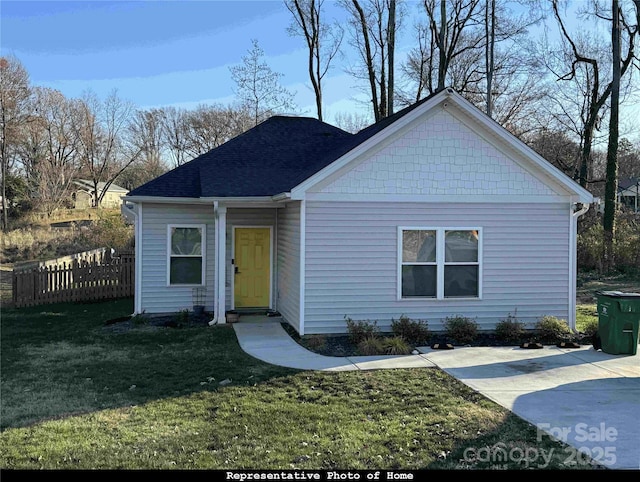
[13,251,135,308]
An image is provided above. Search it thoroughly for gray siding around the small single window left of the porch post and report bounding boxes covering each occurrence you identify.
[141,203,215,313]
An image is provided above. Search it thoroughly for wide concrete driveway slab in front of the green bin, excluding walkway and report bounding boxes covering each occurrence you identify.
[420,347,640,470]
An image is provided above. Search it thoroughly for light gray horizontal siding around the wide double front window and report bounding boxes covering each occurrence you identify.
[305,201,570,334]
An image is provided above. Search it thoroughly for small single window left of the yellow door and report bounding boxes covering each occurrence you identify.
[167,225,205,286]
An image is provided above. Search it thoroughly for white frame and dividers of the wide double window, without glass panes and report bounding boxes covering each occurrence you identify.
[397,226,484,302]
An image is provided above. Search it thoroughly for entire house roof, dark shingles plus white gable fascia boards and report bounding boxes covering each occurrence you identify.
[128,89,592,202]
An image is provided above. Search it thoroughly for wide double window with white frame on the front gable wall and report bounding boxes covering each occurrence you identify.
[398,227,482,299]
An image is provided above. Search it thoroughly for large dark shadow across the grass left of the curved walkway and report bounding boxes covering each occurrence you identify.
[0,299,297,430]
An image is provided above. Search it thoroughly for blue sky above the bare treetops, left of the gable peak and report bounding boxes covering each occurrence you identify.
[0,0,384,121]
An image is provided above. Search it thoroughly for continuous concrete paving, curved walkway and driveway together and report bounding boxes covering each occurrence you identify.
[234,316,640,470]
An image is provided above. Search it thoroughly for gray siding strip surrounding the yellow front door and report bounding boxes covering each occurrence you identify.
[226,208,278,309]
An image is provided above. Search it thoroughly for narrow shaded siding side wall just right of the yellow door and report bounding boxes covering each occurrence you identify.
[276,202,300,331]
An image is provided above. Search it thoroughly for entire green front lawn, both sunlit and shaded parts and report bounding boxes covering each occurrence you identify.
[0,300,600,469]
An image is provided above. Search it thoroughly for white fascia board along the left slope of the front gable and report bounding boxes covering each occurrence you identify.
[291,90,448,200]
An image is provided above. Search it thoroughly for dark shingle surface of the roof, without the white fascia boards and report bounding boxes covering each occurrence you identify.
[129,99,427,198]
